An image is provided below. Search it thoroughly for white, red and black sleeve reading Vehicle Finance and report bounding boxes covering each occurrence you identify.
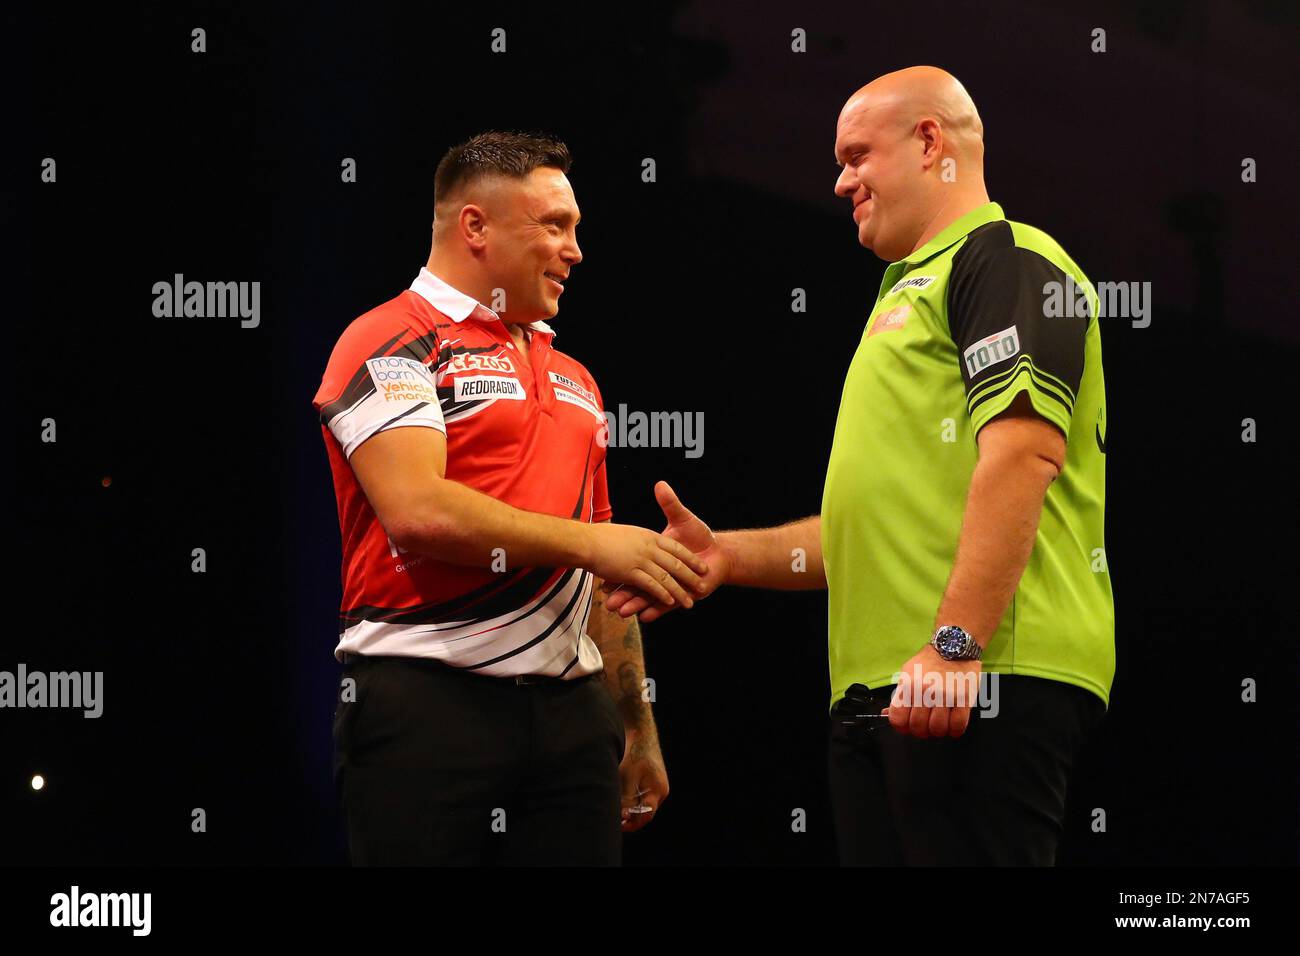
[312,316,447,458]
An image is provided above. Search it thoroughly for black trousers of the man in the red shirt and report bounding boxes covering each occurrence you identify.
[334,656,625,866]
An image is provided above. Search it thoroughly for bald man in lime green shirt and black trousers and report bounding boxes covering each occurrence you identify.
[607,66,1114,865]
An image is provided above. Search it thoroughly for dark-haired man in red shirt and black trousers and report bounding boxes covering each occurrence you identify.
[313,133,707,865]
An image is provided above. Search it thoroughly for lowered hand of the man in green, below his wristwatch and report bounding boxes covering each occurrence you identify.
[885,644,983,737]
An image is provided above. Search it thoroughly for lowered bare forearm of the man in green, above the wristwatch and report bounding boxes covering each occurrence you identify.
[935,454,1057,646]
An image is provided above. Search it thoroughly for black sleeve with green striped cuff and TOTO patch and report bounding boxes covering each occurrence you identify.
[948,246,1095,434]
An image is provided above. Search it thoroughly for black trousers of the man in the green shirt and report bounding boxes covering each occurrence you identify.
[829,674,1105,866]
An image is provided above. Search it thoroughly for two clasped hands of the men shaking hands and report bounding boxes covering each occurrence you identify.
[590,481,731,623]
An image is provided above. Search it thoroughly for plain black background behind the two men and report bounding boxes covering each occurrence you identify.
[0,0,1300,865]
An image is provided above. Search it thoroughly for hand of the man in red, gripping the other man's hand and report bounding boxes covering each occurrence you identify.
[589,523,709,608]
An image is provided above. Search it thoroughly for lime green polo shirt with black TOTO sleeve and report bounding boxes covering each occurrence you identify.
[822,203,1115,705]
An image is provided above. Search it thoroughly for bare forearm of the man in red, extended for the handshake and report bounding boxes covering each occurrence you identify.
[386,479,592,567]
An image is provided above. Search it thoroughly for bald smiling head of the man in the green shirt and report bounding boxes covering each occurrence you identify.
[835,66,988,261]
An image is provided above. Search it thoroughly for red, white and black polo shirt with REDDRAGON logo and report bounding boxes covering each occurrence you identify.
[312,269,612,679]
